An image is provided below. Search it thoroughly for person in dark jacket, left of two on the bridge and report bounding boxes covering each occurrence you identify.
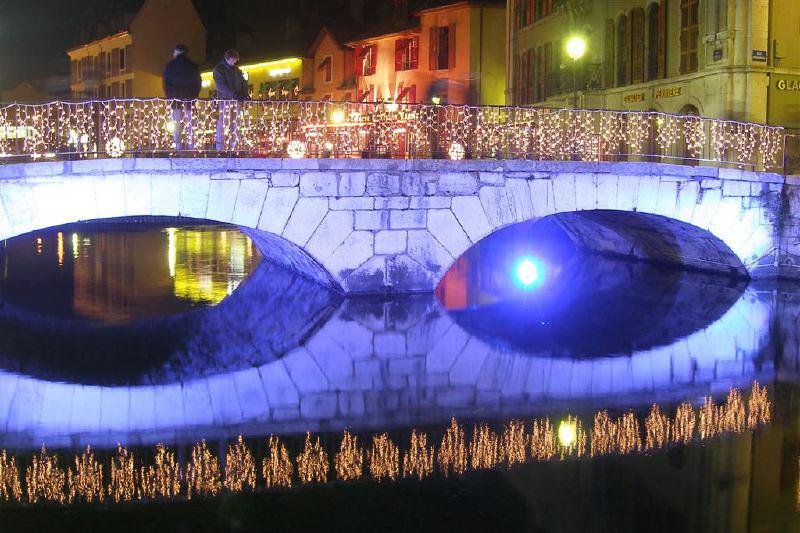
[164,44,202,151]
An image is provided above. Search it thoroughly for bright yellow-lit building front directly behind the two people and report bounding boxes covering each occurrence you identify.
[200,56,312,100]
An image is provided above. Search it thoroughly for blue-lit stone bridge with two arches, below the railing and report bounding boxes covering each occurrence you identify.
[0,158,800,293]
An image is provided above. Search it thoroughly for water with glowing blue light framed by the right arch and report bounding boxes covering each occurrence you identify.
[437,213,746,357]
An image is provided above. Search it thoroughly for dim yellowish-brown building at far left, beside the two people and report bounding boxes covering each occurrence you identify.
[67,0,205,98]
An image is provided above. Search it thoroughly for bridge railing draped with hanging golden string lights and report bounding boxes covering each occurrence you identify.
[0,99,785,170]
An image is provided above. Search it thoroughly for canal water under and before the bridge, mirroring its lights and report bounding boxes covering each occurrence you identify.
[0,219,800,531]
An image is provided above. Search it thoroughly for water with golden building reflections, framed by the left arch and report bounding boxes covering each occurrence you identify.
[0,219,261,323]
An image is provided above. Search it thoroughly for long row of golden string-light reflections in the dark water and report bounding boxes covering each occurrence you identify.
[0,382,772,506]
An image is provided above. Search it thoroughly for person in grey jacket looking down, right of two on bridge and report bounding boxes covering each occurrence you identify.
[214,50,250,152]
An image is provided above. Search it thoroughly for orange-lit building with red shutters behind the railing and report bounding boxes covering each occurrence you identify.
[348,1,505,105]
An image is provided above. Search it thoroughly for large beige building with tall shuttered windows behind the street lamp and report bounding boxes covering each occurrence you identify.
[506,0,800,127]
